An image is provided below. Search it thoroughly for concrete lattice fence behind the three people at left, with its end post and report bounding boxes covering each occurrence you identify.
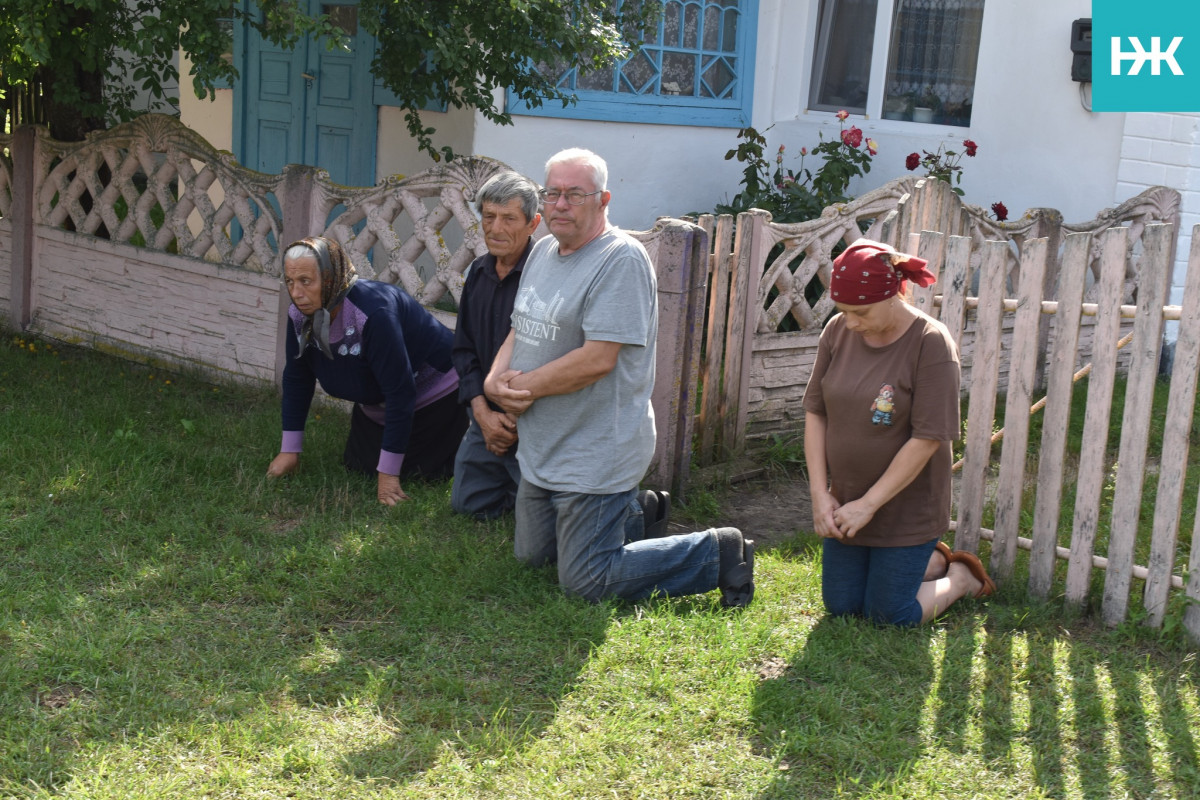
[0,115,708,492]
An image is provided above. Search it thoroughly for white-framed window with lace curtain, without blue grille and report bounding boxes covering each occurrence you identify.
[809,0,984,127]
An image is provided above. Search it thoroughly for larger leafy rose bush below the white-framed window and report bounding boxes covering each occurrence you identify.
[715,112,877,222]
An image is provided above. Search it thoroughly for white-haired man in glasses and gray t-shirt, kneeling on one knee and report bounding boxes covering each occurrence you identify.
[484,149,754,607]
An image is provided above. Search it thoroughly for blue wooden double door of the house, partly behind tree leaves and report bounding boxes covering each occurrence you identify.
[234,0,378,186]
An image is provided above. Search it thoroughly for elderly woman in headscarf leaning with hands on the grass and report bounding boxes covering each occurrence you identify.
[266,236,467,505]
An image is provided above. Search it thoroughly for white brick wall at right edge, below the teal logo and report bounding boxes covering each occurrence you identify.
[1112,113,1200,342]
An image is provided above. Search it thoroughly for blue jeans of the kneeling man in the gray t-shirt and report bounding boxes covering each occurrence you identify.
[512,480,720,602]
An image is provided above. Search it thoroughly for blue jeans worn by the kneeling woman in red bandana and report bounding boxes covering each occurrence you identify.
[821,539,937,627]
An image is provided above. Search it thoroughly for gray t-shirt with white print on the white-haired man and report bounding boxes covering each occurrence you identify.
[511,221,659,494]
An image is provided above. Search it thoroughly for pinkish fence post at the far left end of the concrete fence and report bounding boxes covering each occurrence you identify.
[8,125,41,330]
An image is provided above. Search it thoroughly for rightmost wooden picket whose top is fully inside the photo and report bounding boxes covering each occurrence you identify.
[1102,223,1174,625]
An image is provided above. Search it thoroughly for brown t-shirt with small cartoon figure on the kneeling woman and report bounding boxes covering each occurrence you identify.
[804,309,960,547]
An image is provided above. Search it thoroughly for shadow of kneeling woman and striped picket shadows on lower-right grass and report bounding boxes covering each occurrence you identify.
[751,582,1200,799]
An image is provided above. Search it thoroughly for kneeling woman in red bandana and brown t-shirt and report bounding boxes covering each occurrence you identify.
[804,239,996,626]
